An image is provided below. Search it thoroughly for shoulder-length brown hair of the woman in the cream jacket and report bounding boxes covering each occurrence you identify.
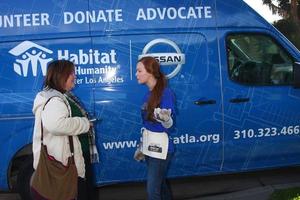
[43,60,75,93]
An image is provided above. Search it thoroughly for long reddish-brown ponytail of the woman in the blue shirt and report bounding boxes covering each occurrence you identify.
[138,56,167,121]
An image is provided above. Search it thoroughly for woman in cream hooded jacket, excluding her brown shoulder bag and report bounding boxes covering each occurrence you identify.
[31,60,97,199]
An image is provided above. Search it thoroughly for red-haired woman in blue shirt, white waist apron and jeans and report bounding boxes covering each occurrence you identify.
[136,57,175,200]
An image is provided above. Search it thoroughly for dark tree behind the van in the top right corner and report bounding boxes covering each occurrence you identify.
[262,0,300,49]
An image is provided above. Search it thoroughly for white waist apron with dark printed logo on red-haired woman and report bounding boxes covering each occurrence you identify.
[142,128,169,160]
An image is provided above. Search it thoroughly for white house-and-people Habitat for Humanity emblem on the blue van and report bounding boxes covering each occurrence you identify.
[9,41,53,77]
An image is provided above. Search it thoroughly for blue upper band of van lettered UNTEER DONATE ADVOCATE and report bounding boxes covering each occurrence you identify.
[0,0,271,41]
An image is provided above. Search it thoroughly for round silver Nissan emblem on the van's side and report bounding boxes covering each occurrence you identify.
[139,38,185,78]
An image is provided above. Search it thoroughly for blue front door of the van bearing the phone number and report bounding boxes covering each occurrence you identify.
[219,29,300,172]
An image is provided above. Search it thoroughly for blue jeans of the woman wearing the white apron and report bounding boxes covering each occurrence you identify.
[146,153,172,200]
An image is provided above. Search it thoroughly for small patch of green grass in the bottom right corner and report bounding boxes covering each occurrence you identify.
[270,187,300,200]
